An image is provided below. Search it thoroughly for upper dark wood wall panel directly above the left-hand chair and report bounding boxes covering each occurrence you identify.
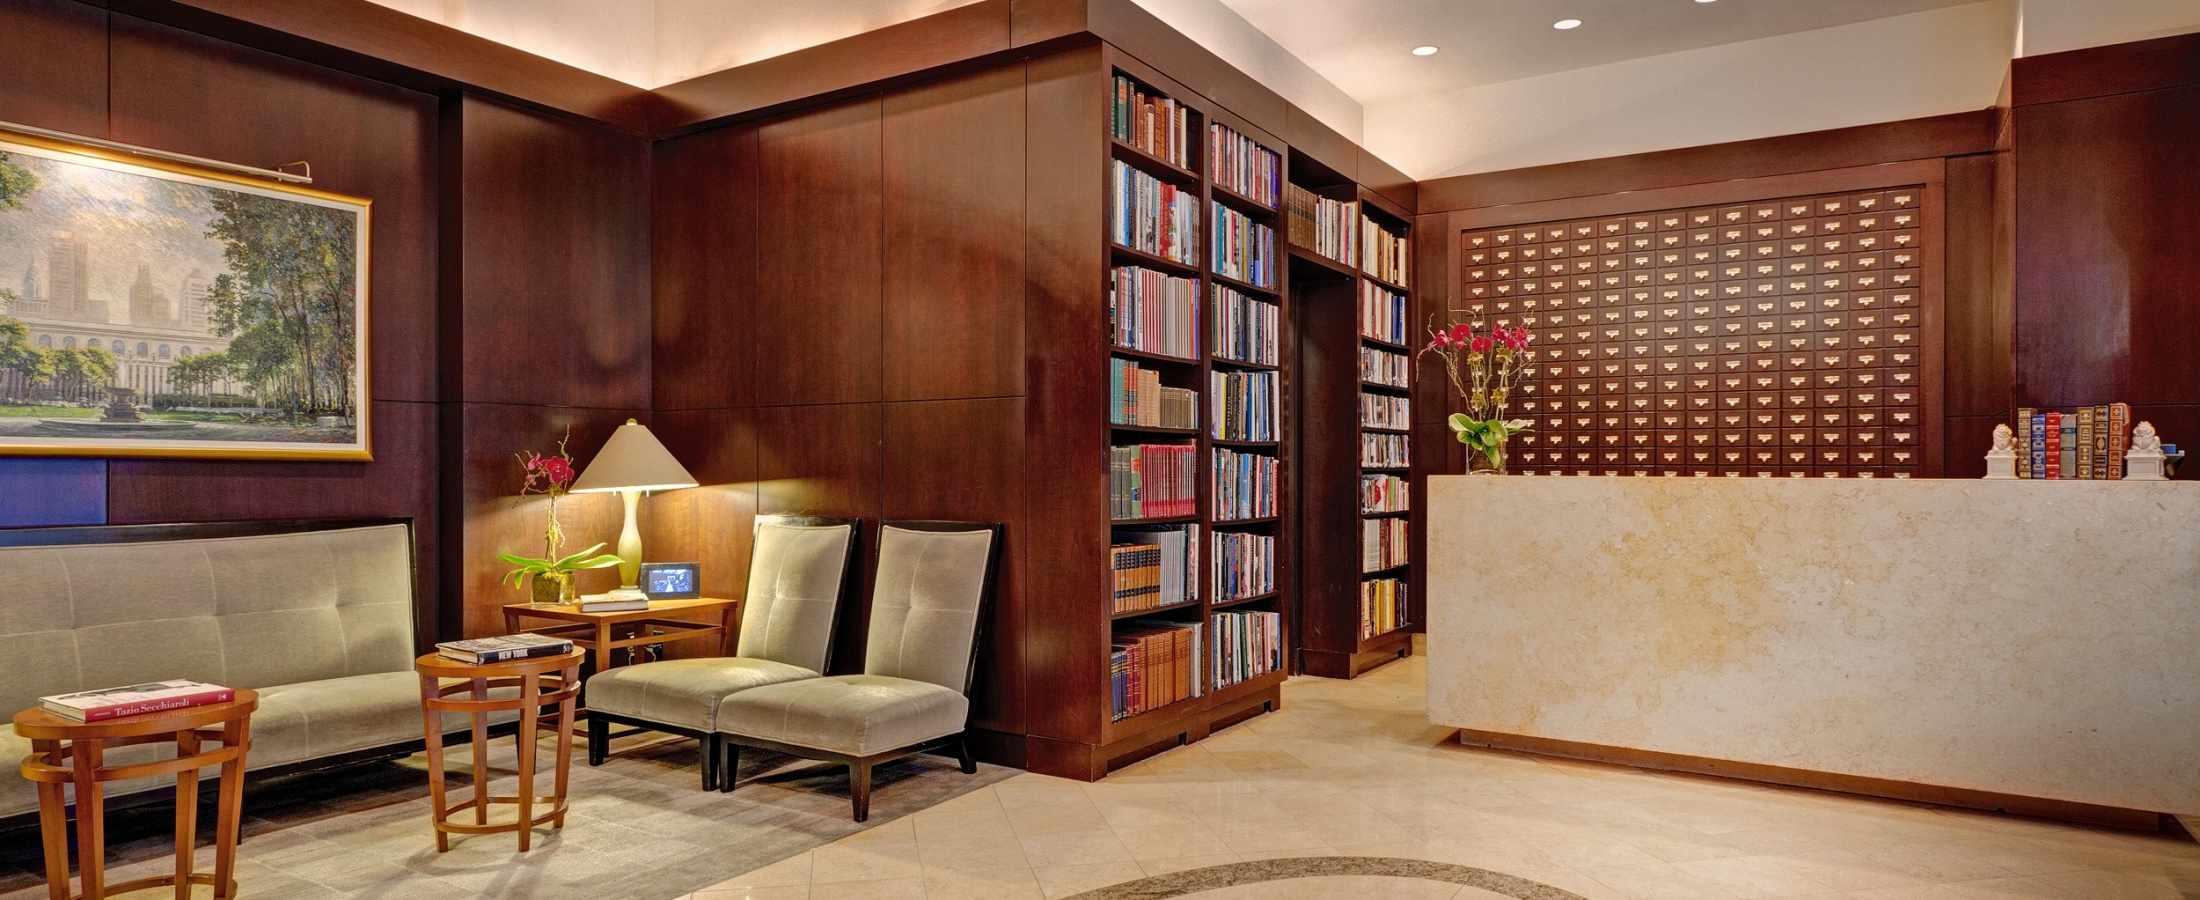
[750,97,882,403]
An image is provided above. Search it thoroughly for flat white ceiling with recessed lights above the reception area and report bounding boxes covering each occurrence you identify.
[1221,0,1988,106]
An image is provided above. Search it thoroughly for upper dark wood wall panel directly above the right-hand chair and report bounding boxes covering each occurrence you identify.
[882,66,1023,400]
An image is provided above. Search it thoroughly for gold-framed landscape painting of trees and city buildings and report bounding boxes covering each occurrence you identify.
[0,130,372,460]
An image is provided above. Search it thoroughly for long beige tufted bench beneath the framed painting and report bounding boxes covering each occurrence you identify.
[0,514,442,816]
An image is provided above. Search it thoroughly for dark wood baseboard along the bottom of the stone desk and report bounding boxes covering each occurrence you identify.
[1459,728,2180,832]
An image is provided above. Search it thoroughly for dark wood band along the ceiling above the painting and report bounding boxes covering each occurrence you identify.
[99,0,660,134]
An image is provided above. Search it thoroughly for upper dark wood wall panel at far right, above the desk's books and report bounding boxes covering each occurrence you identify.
[2015,86,2200,407]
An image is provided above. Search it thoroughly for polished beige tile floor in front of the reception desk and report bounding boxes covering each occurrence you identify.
[691,646,2200,900]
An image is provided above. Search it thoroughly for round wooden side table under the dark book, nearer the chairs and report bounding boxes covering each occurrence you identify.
[414,649,585,854]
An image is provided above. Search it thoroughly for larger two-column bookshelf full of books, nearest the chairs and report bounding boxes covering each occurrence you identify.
[1095,56,1296,777]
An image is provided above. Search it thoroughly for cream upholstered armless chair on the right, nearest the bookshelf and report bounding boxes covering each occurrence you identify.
[717,522,1001,821]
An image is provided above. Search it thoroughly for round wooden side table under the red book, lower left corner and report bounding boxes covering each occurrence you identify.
[15,691,260,900]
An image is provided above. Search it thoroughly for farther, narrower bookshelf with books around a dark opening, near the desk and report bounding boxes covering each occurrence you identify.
[1289,152,1421,678]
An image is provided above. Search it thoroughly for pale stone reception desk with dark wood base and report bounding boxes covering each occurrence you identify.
[1428,475,2200,823]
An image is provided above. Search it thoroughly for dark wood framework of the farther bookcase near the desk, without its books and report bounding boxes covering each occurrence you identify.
[1289,154,1421,678]
